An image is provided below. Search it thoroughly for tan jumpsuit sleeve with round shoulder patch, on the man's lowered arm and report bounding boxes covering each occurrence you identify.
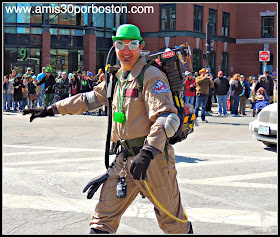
[143,67,178,152]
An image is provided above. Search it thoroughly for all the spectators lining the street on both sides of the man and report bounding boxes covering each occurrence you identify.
[3,66,277,119]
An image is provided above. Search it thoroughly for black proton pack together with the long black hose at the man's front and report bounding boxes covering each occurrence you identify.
[105,45,198,169]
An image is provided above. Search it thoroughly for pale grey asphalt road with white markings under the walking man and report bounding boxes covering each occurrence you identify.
[2,107,278,235]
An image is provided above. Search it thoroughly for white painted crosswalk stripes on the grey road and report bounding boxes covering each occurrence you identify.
[2,145,277,234]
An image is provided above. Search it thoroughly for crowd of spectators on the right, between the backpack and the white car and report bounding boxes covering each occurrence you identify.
[184,68,277,123]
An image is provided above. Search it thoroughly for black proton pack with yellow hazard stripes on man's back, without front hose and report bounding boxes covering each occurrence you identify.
[137,47,196,144]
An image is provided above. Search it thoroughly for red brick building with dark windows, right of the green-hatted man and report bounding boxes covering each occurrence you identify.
[127,3,278,77]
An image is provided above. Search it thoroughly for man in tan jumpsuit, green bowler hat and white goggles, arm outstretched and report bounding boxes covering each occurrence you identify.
[24,24,192,234]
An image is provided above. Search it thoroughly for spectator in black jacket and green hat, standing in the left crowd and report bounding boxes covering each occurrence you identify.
[37,66,55,107]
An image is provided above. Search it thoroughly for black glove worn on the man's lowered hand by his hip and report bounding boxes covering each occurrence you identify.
[130,149,153,180]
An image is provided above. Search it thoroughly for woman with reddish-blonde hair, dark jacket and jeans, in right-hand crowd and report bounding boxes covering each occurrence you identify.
[229,73,243,116]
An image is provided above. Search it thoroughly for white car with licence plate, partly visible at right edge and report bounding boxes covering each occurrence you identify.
[249,103,278,146]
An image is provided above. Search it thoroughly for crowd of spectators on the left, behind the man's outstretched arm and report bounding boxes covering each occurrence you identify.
[3,66,107,115]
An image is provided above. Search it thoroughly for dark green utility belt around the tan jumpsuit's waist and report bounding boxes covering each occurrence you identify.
[113,136,146,156]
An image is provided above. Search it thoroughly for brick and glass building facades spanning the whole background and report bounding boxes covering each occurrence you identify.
[3,2,278,77]
